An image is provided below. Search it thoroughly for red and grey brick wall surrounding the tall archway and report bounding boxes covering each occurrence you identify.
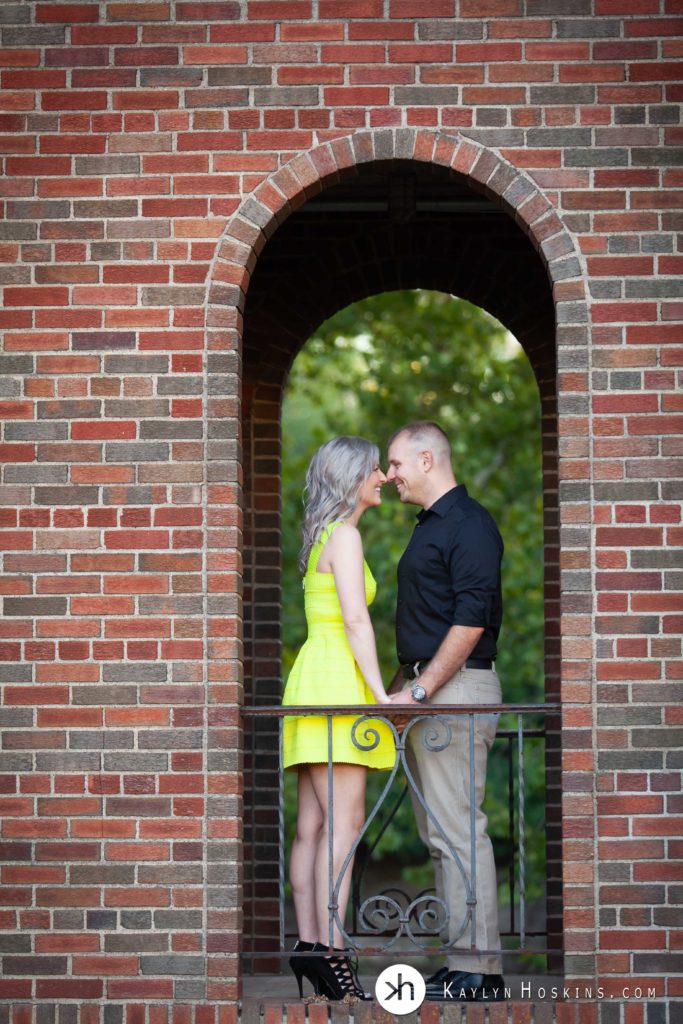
[0,0,683,1024]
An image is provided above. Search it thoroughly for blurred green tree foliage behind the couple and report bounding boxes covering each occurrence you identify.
[283,291,544,929]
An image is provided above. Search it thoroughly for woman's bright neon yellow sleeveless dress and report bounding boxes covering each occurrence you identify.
[283,522,395,770]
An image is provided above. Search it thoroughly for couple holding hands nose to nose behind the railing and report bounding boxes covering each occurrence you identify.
[283,421,503,999]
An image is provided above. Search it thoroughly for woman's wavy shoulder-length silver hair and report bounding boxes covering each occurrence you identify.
[299,436,380,572]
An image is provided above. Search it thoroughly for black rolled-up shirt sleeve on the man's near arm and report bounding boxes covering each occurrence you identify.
[449,516,502,629]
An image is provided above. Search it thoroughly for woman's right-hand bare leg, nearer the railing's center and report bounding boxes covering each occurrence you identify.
[309,764,368,948]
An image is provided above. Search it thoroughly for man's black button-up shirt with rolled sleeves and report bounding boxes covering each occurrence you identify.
[396,483,503,665]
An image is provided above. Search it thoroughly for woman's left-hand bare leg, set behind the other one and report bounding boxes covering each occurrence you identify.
[290,765,327,942]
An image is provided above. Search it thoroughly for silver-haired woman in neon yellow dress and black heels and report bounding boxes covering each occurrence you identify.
[283,437,395,999]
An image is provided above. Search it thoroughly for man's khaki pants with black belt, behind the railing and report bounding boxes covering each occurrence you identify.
[407,669,502,974]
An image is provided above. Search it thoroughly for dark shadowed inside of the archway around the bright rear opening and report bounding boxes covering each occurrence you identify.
[235,155,568,970]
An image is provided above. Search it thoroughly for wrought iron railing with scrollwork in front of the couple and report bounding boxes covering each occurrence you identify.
[242,703,560,956]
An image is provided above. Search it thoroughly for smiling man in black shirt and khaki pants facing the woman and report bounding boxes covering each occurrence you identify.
[387,421,504,999]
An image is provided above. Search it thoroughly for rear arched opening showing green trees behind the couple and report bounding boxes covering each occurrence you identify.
[274,290,546,976]
